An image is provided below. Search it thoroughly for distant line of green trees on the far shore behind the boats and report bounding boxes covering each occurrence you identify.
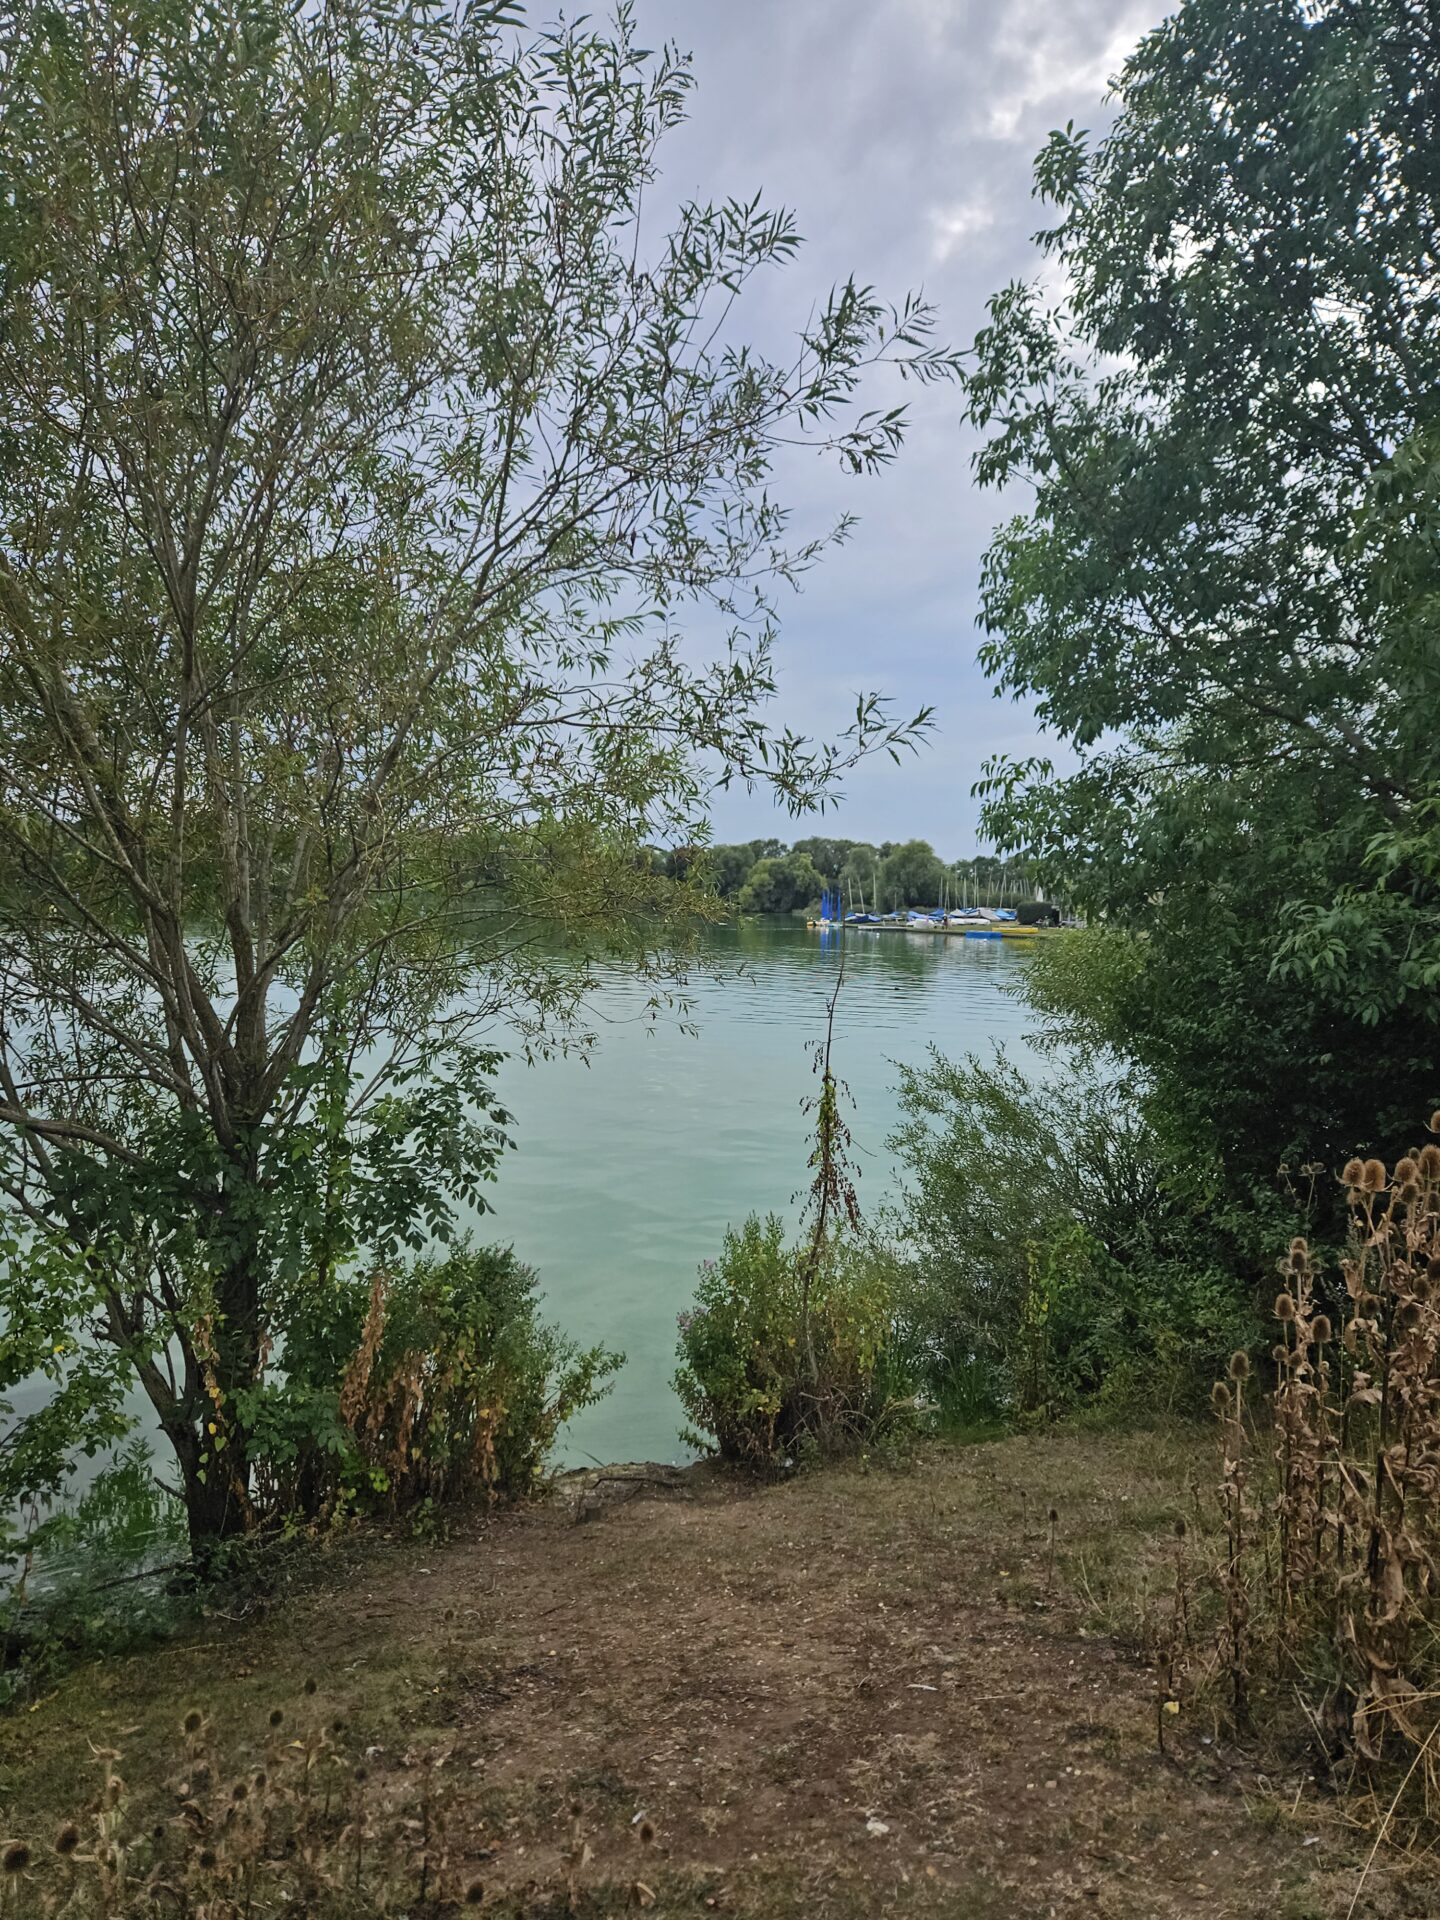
[649,835,1033,914]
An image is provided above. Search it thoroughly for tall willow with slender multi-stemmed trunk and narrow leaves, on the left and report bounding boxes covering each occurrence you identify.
[0,0,952,1540]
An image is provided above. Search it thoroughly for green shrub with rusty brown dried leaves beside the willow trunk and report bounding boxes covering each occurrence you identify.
[246,1244,622,1523]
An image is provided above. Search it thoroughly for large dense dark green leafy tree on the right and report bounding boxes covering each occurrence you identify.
[966,0,1440,1231]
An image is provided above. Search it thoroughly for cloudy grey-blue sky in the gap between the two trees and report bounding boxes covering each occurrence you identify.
[636,0,1167,856]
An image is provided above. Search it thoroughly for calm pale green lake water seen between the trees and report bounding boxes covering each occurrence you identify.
[476,922,1027,1465]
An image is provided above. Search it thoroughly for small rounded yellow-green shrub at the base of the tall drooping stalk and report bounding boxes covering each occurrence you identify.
[676,1213,904,1469]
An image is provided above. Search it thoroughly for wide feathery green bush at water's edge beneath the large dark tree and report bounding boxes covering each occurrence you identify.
[883,1054,1260,1419]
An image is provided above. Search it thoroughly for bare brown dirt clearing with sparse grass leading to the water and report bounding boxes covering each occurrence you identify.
[0,1434,1440,1920]
